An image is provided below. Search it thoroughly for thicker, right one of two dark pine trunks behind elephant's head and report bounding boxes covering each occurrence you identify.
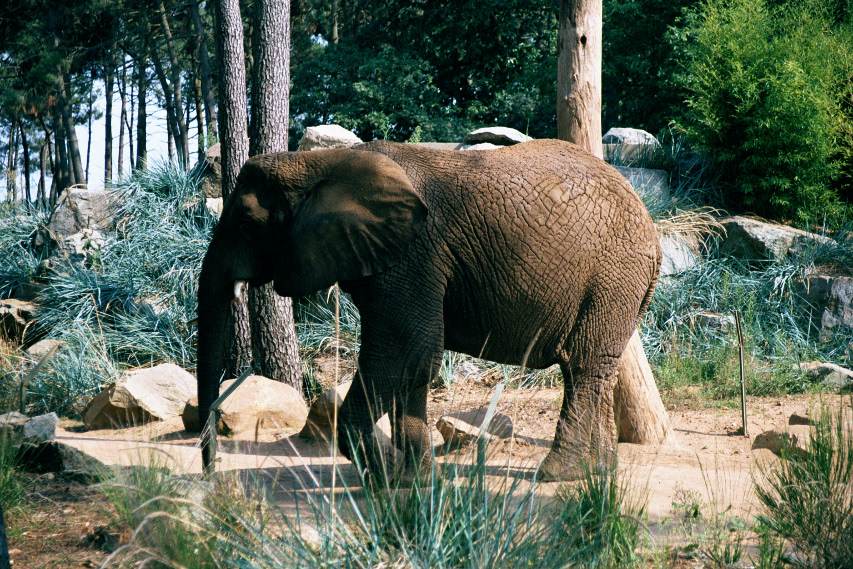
[249,0,302,391]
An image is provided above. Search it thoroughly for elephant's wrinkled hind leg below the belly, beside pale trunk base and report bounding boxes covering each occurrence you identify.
[539,366,617,480]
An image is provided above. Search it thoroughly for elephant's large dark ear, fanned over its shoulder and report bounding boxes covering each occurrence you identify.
[274,149,427,296]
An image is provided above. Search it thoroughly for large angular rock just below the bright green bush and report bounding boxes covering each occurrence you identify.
[720,216,835,261]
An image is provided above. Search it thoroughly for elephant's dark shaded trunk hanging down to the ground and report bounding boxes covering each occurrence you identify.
[196,233,250,473]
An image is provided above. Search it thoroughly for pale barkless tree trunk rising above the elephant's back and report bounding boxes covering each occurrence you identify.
[557,0,604,158]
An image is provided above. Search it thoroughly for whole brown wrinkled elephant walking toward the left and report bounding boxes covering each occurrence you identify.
[198,140,661,479]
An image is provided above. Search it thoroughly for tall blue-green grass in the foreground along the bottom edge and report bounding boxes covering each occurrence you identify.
[103,446,642,569]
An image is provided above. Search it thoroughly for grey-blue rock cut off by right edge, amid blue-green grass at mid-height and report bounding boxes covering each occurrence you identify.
[791,275,853,337]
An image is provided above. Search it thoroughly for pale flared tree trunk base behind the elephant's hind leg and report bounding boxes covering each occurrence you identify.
[613,332,670,444]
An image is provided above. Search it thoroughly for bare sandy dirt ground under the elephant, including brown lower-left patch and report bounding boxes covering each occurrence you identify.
[7,383,849,568]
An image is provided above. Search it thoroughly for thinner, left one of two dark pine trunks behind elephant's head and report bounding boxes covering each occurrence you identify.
[215,0,252,372]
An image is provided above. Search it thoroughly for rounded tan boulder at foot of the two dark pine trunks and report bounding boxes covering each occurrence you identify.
[215,375,308,435]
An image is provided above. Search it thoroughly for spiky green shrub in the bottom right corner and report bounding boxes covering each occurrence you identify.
[755,406,853,569]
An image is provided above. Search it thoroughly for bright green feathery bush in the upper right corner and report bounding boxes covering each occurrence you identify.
[682,0,853,223]
